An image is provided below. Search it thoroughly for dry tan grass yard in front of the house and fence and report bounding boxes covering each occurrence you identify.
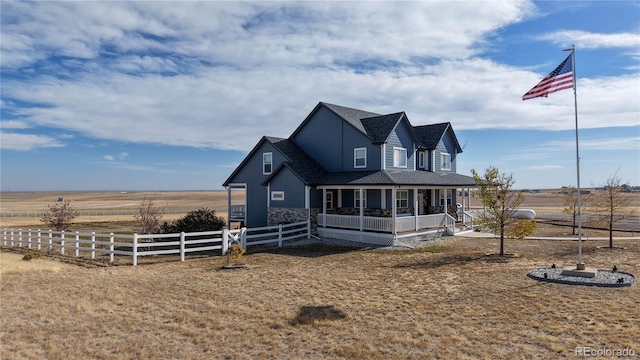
[0,238,640,359]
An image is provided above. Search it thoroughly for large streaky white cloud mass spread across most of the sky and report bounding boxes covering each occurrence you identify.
[2,1,640,153]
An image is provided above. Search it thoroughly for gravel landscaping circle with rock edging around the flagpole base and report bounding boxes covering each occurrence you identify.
[527,268,636,287]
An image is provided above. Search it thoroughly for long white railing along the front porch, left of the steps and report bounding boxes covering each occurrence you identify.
[318,214,455,233]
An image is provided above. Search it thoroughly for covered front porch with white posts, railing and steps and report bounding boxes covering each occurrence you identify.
[317,186,472,245]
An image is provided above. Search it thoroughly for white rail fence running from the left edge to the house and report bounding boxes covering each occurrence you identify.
[2,221,311,266]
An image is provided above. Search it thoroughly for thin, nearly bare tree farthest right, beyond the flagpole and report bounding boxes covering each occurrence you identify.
[591,172,635,248]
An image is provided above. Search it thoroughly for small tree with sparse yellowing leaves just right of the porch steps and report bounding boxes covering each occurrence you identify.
[471,166,535,256]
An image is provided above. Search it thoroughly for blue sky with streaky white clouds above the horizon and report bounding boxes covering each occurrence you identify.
[0,1,640,191]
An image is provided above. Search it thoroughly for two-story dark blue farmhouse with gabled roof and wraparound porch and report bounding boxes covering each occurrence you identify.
[223,102,475,244]
